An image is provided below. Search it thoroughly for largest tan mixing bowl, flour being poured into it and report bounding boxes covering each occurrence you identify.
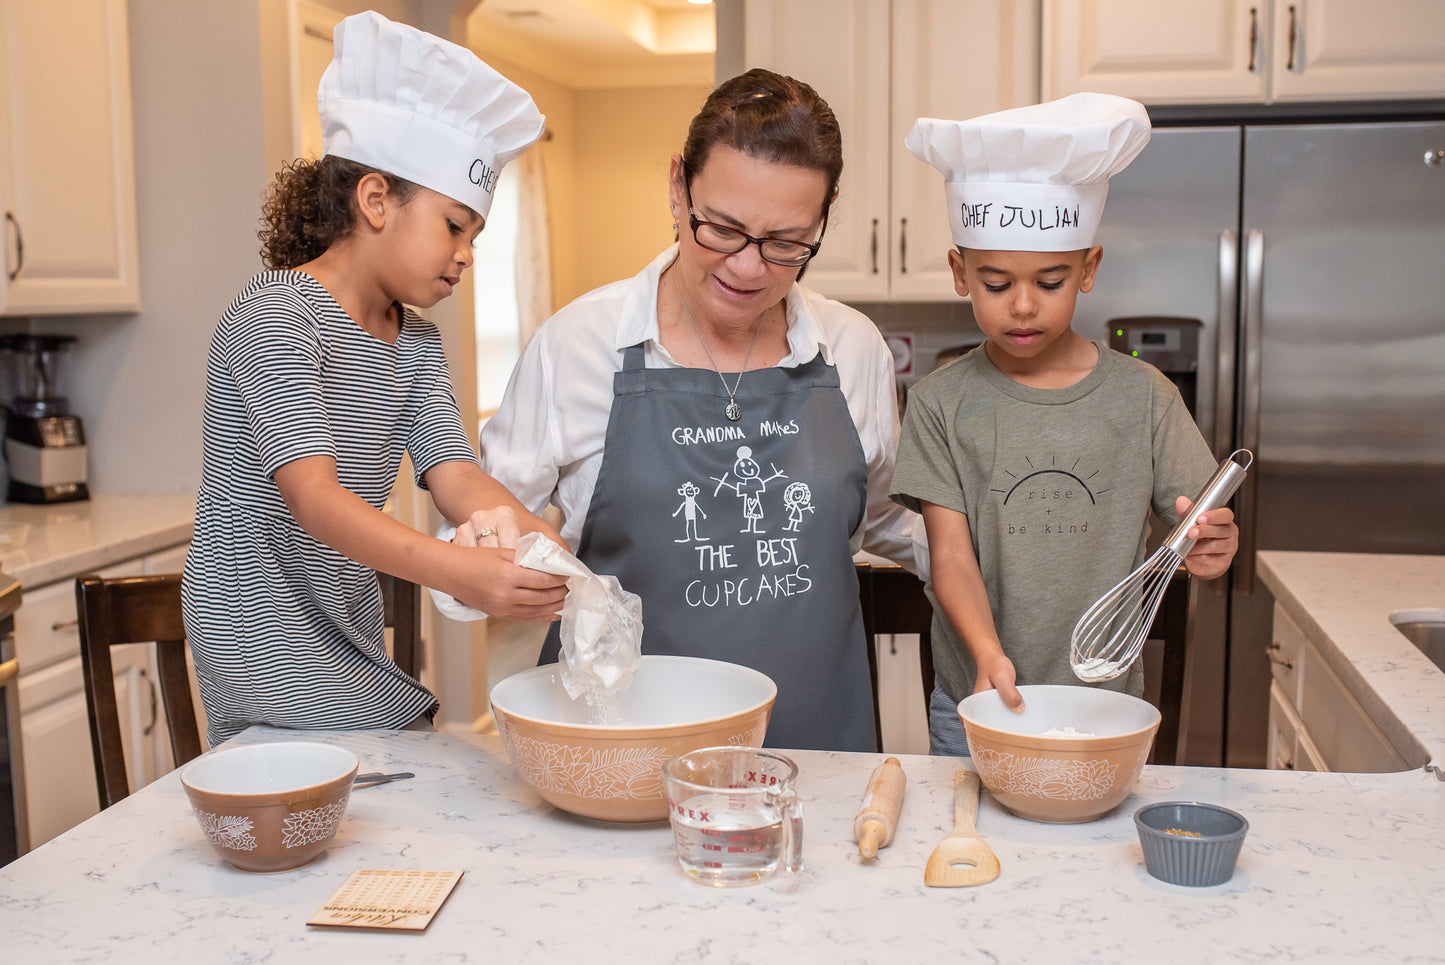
[491,654,777,823]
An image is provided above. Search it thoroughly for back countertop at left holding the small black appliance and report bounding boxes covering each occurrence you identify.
[0,493,195,589]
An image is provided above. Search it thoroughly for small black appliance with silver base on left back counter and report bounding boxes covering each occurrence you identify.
[0,334,90,503]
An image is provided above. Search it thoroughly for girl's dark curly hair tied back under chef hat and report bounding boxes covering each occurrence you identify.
[256,156,416,269]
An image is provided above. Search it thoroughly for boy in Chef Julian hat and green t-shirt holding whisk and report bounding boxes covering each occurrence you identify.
[892,94,1238,756]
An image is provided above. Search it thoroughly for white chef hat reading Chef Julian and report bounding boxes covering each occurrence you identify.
[903,94,1149,251]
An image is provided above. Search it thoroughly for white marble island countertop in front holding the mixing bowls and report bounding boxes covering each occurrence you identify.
[0,728,1445,965]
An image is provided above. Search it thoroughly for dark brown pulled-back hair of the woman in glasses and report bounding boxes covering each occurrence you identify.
[682,68,842,217]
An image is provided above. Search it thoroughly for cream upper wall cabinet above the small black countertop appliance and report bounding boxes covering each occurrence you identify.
[0,0,140,315]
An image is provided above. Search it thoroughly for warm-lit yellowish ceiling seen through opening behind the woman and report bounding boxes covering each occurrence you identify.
[467,0,715,88]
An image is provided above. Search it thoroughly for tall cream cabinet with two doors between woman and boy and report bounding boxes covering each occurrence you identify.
[744,0,1039,302]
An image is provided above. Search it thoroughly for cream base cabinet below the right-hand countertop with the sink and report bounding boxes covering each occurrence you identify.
[1267,607,1409,773]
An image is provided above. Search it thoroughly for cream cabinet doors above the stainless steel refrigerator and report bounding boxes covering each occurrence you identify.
[1040,0,1445,104]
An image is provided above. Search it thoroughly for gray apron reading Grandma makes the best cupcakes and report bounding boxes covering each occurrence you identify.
[539,345,877,751]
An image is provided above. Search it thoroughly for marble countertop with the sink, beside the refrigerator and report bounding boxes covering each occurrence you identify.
[1259,550,1445,767]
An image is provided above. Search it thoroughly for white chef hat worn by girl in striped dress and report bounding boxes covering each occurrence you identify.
[316,10,546,218]
